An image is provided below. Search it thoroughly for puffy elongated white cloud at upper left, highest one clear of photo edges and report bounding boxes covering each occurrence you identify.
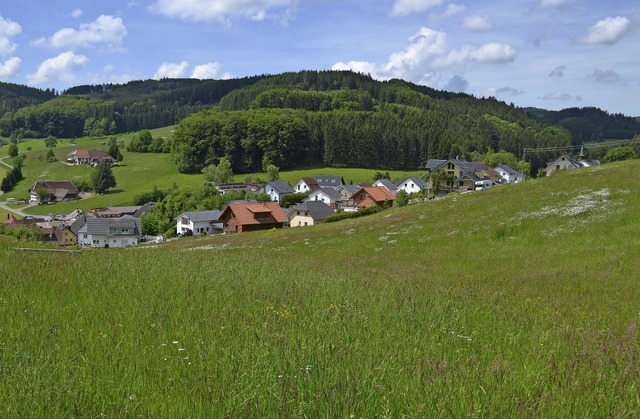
[31,15,127,49]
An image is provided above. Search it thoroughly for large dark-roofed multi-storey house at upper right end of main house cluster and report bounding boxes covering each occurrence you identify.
[425,159,499,192]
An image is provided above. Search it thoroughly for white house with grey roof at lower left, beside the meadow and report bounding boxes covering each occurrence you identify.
[71,214,142,247]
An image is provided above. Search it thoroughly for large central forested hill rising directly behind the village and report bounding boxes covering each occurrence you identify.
[173,71,572,173]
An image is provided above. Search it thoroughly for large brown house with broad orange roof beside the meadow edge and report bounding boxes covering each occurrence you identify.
[218,201,289,233]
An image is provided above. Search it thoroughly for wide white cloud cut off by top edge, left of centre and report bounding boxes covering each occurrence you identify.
[149,0,297,22]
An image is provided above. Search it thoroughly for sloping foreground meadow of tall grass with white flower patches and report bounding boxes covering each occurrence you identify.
[0,161,640,417]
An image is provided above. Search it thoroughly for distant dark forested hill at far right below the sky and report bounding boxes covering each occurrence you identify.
[526,107,640,143]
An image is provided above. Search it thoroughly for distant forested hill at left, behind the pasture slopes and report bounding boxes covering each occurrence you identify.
[0,76,266,138]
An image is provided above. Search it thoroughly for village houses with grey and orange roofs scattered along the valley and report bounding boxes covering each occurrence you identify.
[4,149,599,248]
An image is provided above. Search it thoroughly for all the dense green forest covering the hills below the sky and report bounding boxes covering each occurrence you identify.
[0,71,640,173]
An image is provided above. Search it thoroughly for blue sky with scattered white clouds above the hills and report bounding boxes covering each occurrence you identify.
[0,0,640,116]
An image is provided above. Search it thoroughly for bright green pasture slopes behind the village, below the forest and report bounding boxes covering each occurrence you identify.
[0,127,420,215]
